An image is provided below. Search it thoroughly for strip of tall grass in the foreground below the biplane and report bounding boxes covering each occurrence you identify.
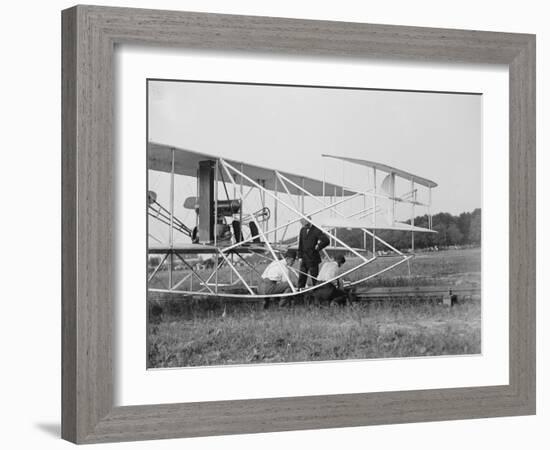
[149,302,481,367]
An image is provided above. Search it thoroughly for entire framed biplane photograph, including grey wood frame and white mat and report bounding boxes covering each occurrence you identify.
[62,6,536,443]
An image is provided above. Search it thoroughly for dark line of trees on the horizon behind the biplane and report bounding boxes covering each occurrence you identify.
[337,208,481,250]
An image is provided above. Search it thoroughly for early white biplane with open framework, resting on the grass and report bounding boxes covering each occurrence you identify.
[147,142,437,299]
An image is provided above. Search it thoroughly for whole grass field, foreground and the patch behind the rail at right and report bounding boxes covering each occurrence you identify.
[148,249,481,367]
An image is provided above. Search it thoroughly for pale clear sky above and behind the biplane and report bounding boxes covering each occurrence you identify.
[148,81,482,244]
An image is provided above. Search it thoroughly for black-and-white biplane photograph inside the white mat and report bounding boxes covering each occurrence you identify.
[148,79,483,369]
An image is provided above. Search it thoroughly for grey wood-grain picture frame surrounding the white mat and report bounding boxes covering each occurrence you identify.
[62,6,535,443]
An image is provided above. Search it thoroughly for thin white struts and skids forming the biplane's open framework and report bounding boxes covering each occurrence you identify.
[148,149,432,299]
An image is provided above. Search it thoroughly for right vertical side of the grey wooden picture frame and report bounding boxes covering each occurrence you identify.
[509,39,536,412]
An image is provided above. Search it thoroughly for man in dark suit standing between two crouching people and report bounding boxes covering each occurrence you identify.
[298,217,330,289]
